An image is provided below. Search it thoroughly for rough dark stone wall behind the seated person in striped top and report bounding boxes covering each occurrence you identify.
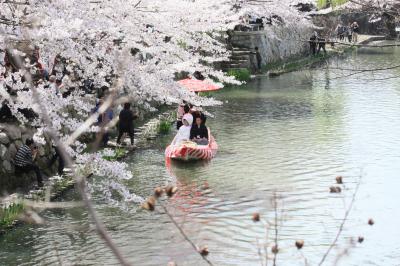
[0,123,55,196]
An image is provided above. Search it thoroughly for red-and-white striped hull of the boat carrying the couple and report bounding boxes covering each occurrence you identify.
[165,135,218,161]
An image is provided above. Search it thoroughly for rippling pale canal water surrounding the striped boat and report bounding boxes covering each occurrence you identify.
[0,42,400,265]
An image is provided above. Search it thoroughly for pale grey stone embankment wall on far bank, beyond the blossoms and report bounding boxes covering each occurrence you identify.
[230,24,313,69]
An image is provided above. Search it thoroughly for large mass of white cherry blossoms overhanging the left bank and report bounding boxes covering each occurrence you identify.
[0,0,308,204]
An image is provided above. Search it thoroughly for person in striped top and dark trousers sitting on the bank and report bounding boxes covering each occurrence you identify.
[14,139,43,187]
